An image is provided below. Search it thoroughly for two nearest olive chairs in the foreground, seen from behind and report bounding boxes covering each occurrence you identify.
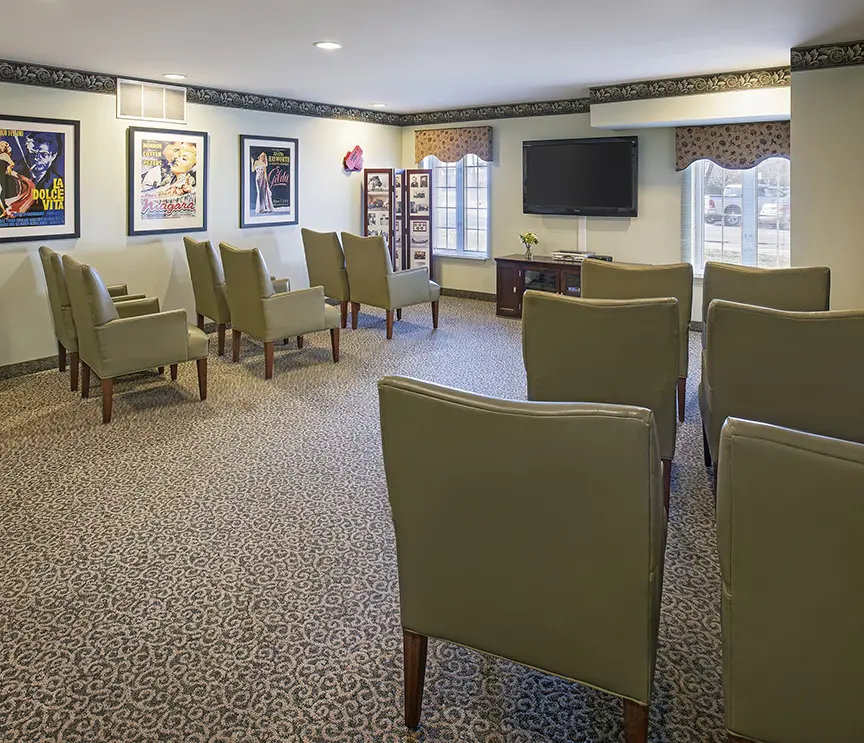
[379,380,864,743]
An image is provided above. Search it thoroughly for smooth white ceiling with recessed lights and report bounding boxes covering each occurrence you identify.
[0,0,864,113]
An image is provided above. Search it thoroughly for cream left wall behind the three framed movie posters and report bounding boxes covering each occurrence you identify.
[0,84,402,366]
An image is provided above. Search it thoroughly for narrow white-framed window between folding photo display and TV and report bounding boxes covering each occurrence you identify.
[421,155,489,259]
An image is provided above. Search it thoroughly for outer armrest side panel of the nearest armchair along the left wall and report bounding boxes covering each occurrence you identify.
[96,310,188,377]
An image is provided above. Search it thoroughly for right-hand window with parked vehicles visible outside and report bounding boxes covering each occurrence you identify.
[681,157,790,276]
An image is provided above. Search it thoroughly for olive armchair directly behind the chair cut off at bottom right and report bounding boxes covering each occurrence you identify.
[699,299,864,466]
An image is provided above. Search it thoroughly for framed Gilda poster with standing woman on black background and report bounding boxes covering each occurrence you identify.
[240,134,298,227]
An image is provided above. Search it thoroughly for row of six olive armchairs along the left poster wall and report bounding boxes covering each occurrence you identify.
[39,230,440,423]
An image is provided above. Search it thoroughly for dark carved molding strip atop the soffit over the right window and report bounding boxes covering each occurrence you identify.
[588,67,792,103]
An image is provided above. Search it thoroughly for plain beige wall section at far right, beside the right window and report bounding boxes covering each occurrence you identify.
[792,67,864,309]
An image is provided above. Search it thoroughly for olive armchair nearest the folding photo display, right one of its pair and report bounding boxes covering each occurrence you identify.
[342,232,441,340]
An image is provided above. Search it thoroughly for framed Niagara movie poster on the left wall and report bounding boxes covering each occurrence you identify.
[128,127,208,235]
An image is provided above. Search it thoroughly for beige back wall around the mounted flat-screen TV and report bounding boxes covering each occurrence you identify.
[402,114,681,308]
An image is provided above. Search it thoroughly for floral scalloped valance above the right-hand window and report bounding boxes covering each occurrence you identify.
[675,121,792,170]
